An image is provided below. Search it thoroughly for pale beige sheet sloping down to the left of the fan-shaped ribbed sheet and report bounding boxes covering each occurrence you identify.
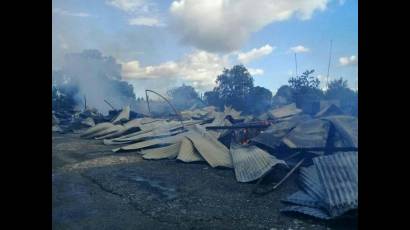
[185,125,232,168]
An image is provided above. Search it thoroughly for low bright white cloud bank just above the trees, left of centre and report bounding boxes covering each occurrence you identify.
[122,50,231,90]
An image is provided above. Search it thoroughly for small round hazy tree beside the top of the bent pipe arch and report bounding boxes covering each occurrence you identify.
[168,84,200,109]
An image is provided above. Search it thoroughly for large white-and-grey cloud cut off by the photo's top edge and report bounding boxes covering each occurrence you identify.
[170,0,329,52]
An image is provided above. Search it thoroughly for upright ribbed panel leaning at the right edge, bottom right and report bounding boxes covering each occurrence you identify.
[313,152,358,217]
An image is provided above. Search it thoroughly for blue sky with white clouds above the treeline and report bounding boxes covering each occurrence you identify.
[52,0,358,96]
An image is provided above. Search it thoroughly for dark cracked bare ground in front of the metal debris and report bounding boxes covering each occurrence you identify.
[52,133,356,230]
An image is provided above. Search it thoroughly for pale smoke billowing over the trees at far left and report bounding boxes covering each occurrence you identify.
[53,50,135,113]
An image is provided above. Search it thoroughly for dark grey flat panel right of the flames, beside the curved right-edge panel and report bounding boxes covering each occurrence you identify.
[283,119,330,148]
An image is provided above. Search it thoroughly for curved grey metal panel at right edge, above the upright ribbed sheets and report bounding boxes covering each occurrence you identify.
[323,116,358,147]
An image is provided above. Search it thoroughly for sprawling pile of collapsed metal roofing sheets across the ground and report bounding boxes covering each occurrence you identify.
[53,99,358,223]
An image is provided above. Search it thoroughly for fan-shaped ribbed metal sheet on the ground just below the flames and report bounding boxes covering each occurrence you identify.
[230,143,286,182]
